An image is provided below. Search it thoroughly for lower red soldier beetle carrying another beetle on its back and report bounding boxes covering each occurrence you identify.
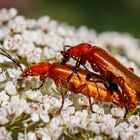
[0,48,125,112]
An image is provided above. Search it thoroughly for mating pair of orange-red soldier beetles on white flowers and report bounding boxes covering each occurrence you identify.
[0,43,140,114]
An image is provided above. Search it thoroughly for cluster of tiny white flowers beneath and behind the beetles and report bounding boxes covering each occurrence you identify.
[0,8,140,140]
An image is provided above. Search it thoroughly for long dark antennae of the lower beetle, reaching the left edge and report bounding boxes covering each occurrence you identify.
[0,48,23,72]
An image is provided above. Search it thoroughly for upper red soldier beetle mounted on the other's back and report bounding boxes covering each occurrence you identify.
[61,43,140,111]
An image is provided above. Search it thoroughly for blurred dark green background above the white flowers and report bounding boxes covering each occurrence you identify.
[0,0,140,38]
